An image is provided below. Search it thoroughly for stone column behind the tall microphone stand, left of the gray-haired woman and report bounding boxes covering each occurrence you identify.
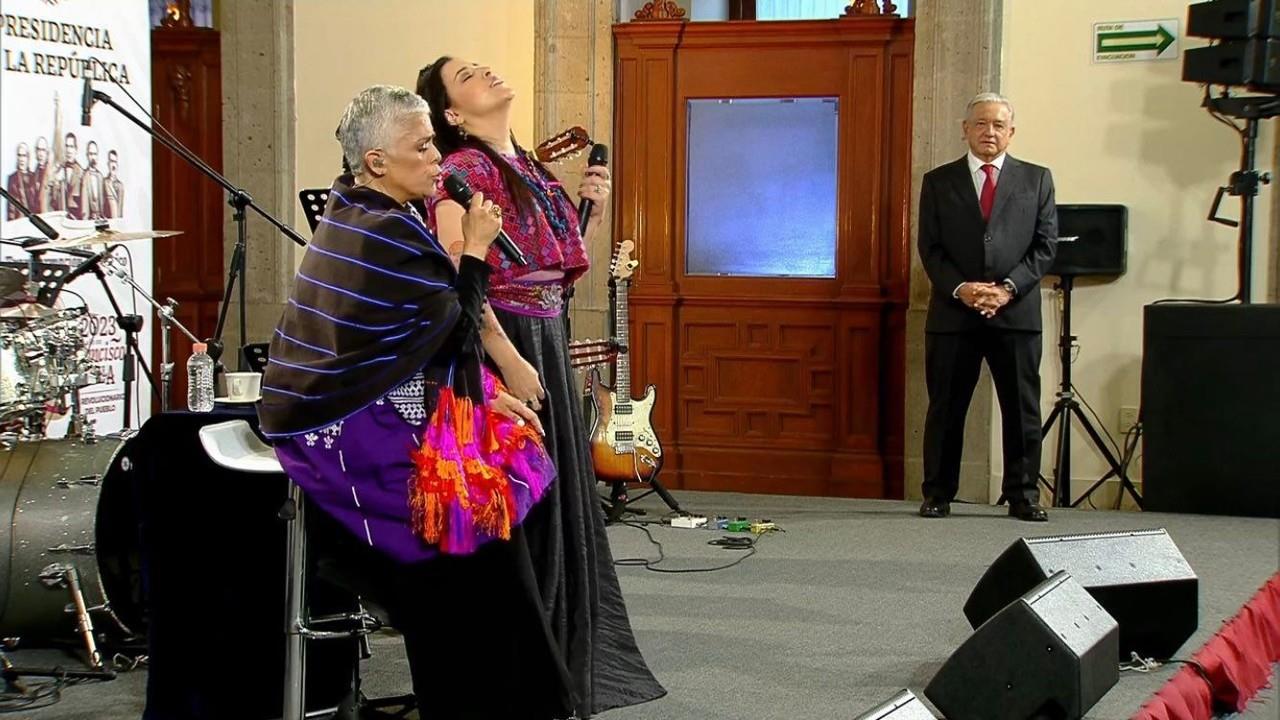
[218,0,301,356]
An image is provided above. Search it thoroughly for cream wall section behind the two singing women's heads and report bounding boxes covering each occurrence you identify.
[293,0,538,240]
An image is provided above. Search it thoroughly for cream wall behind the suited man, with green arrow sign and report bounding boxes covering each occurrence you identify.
[993,0,1275,497]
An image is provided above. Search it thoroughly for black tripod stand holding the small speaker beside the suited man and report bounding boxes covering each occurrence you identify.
[1041,273,1142,507]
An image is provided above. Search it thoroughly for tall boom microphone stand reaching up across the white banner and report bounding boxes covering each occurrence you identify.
[85,90,307,370]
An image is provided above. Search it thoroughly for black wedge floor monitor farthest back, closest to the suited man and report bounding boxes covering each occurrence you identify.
[964,529,1199,660]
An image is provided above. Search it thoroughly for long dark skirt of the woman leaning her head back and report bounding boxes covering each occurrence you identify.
[494,307,667,717]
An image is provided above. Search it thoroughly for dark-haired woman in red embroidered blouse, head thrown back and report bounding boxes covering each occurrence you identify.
[417,56,666,717]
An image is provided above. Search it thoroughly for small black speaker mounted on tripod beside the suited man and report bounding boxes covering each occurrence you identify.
[1048,205,1129,277]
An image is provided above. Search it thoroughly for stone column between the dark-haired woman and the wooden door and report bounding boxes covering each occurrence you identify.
[537,0,616,338]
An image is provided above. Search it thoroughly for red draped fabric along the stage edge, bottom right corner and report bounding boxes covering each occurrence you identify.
[1133,573,1280,720]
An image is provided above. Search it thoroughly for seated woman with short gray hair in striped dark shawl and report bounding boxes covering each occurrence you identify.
[259,85,568,717]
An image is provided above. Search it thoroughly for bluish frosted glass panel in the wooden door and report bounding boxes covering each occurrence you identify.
[685,97,840,278]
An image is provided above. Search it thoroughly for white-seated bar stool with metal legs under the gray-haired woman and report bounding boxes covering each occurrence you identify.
[200,420,396,720]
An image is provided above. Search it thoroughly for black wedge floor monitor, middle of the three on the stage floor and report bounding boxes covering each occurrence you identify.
[924,573,1120,720]
